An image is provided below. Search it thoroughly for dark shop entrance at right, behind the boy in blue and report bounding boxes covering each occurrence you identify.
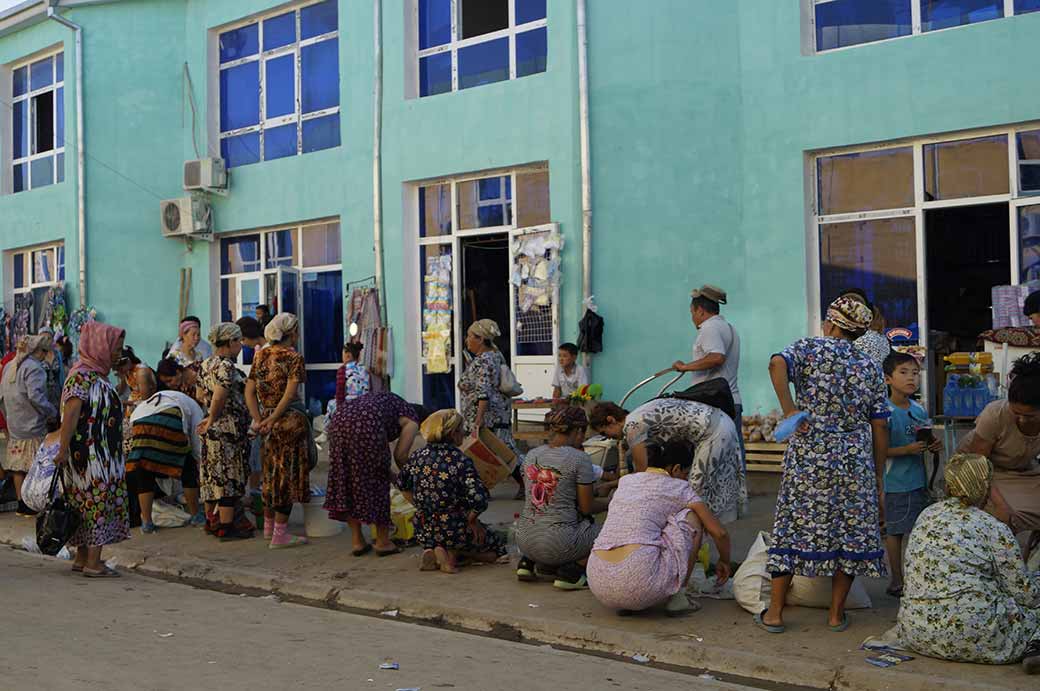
[925,204,1011,354]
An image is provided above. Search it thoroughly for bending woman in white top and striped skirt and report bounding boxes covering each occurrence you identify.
[123,367,206,535]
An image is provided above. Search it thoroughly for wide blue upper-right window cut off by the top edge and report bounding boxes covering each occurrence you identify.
[807,0,1040,52]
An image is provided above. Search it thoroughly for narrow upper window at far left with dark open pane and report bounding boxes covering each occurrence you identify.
[10,53,64,193]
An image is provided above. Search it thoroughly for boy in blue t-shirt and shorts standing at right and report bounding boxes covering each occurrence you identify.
[884,352,942,597]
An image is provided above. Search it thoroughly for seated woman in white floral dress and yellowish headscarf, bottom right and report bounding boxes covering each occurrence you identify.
[898,454,1040,674]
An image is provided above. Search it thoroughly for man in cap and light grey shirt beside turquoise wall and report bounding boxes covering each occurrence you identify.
[672,285,744,457]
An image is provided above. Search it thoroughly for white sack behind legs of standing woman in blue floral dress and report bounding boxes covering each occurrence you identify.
[733,532,870,614]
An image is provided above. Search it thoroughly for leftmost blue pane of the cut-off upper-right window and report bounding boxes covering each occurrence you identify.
[815,0,913,50]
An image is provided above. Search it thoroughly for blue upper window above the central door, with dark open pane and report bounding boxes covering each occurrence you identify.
[416,0,548,97]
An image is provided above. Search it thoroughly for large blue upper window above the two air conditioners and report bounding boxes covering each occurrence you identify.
[219,0,340,168]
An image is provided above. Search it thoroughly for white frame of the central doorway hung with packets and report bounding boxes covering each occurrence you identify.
[405,163,560,401]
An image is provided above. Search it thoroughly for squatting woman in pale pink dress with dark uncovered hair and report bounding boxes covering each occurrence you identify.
[588,442,730,616]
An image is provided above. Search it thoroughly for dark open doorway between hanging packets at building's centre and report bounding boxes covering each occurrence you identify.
[462,233,512,362]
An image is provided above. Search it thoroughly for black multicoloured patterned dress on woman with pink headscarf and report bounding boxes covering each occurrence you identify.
[61,372,130,547]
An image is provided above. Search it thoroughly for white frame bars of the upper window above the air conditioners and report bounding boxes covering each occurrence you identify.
[213,0,342,164]
